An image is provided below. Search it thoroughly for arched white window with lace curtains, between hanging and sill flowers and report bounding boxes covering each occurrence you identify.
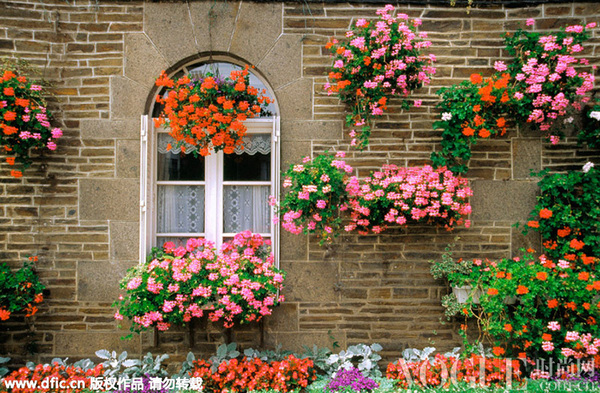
[140,61,279,261]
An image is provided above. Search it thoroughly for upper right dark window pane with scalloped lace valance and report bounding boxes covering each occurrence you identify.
[223,134,271,181]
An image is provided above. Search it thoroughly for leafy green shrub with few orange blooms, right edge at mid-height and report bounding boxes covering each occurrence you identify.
[527,163,600,265]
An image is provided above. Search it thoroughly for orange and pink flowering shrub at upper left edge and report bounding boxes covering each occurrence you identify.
[0,64,62,177]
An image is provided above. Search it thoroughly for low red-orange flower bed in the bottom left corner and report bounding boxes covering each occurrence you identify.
[0,363,103,393]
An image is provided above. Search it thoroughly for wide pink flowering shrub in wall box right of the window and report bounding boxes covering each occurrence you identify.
[345,165,472,234]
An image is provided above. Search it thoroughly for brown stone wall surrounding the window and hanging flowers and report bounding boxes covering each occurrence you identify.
[0,0,600,361]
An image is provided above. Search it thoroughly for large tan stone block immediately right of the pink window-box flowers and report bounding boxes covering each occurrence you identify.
[281,262,339,302]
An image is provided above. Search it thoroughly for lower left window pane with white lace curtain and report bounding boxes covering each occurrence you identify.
[156,186,204,233]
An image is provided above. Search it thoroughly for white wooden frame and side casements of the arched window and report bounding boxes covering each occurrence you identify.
[140,115,281,266]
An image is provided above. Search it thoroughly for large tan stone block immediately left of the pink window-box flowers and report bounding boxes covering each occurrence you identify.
[77,261,137,302]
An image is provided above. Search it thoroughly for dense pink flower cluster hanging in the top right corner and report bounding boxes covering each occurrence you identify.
[514,23,596,144]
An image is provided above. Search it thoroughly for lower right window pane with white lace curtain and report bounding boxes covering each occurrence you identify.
[223,186,271,233]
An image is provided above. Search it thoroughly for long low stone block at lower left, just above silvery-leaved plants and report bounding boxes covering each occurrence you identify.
[54,330,141,361]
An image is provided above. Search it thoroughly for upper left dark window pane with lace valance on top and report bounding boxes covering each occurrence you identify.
[157,133,204,181]
